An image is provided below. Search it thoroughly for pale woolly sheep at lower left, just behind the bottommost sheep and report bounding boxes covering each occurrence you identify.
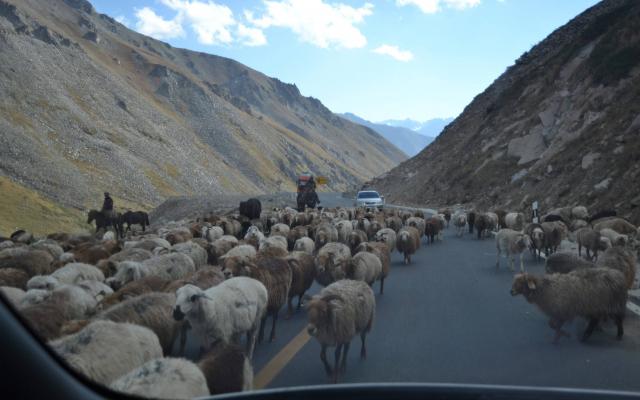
[49,320,162,385]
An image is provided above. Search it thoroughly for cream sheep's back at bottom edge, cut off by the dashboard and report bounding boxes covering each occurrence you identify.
[109,358,209,399]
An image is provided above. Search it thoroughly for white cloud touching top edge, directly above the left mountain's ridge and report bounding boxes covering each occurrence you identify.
[162,0,236,45]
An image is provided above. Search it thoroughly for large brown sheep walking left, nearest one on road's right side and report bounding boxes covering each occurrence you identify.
[511,268,627,343]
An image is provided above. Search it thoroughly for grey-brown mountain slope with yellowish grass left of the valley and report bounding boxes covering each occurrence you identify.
[0,0,406,234]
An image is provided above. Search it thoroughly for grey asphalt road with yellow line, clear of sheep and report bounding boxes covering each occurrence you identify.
[178,198,640,390]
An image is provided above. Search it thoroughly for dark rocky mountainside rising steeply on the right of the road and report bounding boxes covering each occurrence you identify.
[372,0,640,224]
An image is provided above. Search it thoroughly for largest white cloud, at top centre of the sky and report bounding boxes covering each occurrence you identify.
[245,0,373,49]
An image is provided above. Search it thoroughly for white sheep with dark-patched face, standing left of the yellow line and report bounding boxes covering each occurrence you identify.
[173,277,268,359]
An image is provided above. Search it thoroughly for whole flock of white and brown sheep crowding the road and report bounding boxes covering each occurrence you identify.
[0,202,638,398]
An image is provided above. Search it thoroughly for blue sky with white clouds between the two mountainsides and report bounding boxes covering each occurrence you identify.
[92,0,597,121]
